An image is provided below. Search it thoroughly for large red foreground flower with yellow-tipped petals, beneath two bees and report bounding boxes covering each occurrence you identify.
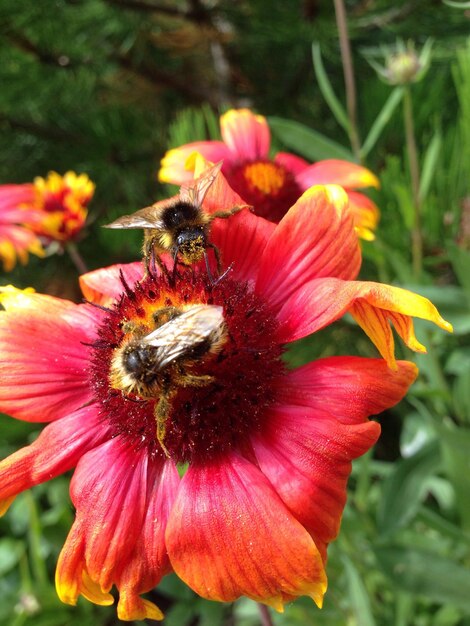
[0,166,450,620]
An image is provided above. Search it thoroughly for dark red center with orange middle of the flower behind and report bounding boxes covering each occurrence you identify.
[227,161,302,222]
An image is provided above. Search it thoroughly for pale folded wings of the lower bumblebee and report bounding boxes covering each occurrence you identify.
[142,304,224,369]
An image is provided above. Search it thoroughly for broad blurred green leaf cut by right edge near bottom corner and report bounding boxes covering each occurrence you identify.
[375,545,470,613]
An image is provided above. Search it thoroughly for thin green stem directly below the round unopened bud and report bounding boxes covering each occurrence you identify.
[403,85,423,278]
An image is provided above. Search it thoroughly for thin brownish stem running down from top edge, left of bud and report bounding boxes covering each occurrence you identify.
[334,0,361,161]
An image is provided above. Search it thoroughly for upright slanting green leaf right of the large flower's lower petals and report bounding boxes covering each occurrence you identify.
[377,441,440,536]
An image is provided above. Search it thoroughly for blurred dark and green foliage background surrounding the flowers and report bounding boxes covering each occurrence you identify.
[0,0,470,626]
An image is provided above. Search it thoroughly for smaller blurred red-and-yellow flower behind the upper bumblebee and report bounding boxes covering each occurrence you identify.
[158,109,379,240]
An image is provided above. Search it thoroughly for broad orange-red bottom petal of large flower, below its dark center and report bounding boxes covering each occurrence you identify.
[166,453,326,611]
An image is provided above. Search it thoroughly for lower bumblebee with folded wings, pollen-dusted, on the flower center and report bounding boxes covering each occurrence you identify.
[109,304,227,456]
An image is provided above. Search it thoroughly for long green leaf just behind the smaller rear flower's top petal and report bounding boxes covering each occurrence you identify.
[268,117,354,161]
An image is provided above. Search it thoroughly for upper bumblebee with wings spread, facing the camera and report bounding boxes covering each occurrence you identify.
[105,161,249,275]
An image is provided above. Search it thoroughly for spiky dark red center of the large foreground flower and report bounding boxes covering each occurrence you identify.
[90,269,284,463]
